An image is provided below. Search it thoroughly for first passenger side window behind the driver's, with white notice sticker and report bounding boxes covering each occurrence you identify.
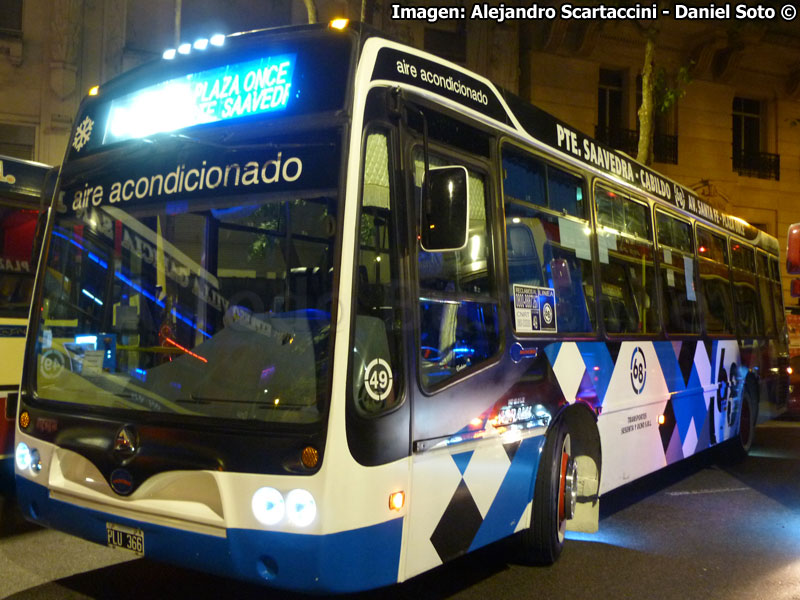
[503,145,595,333]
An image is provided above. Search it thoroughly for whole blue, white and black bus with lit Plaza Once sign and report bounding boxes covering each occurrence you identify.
[16,25,787,592]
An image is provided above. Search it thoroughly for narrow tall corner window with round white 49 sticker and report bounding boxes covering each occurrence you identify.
[351,132,403,416]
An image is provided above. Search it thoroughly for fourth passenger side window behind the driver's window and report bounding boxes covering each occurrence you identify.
[697,227,735,335]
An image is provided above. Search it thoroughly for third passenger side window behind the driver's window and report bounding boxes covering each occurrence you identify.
[656,210,700,334]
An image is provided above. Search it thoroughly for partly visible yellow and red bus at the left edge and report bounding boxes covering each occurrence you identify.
[0,156,50,488]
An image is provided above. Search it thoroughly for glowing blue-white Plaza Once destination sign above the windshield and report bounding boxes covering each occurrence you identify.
[103,54,296,144]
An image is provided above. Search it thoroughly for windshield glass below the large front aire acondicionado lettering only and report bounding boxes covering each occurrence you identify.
[37,192,337,423]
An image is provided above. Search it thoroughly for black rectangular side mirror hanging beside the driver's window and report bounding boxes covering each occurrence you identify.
[420,166,469,252]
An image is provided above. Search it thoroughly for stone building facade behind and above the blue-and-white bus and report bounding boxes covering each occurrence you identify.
[0,0,800,306]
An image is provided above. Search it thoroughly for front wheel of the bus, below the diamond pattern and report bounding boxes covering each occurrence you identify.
[520,421,578,565]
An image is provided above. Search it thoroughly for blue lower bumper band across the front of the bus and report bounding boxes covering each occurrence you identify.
[16,477,403,593]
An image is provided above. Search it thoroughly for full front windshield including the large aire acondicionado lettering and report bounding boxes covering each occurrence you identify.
[35,129,341,424]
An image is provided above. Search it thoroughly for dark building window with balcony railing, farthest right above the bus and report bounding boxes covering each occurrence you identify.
[732,98,780,180]
